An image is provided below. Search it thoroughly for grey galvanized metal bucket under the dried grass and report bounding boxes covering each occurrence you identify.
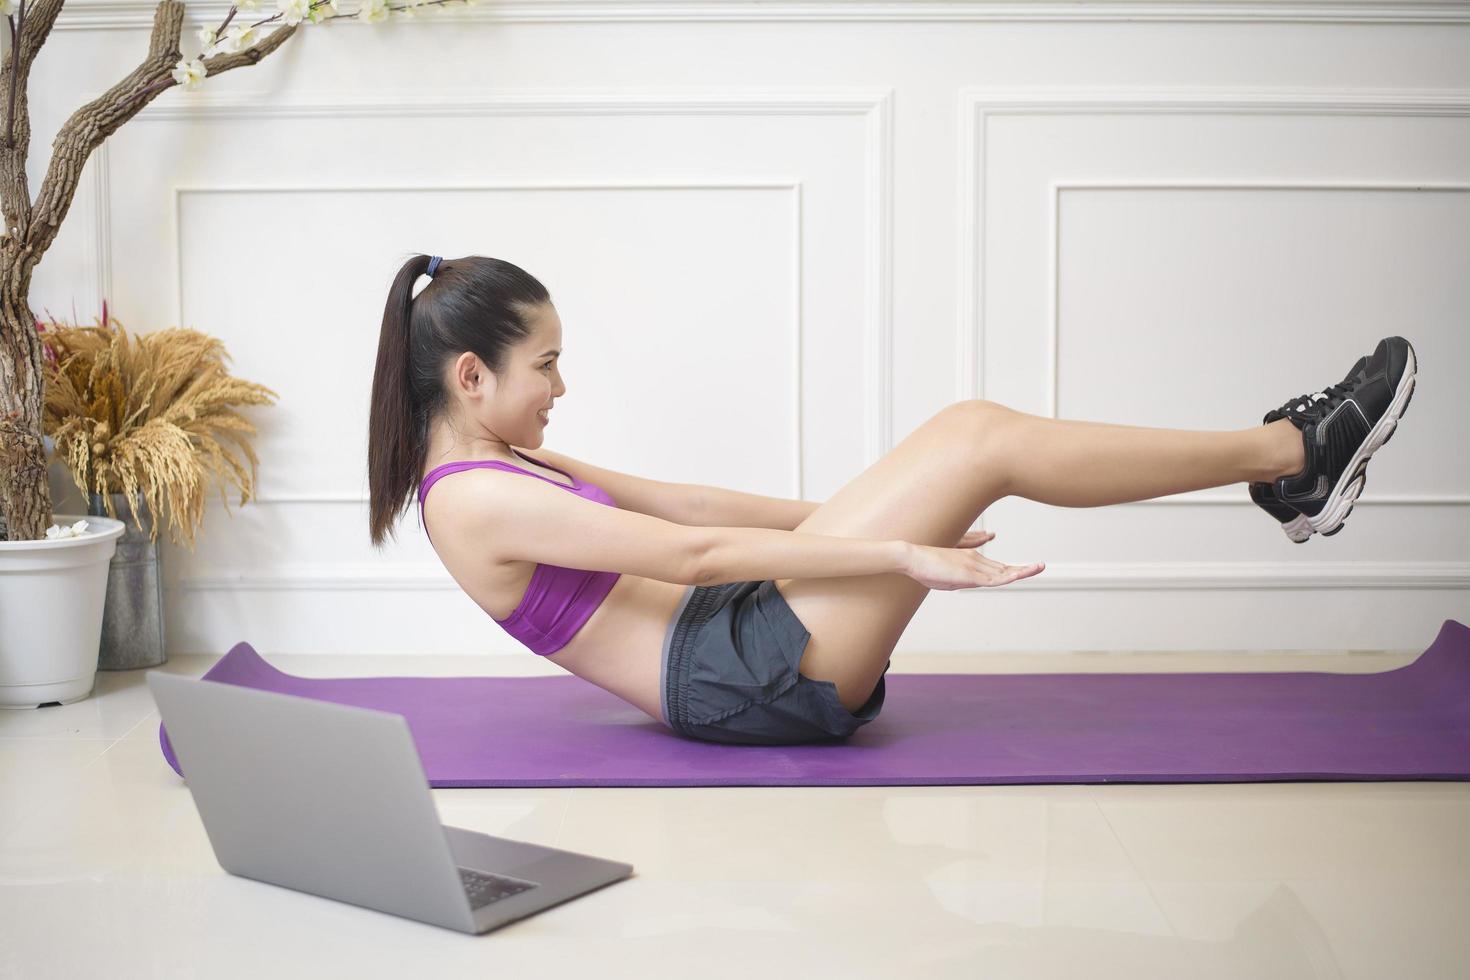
[87,494,168,670]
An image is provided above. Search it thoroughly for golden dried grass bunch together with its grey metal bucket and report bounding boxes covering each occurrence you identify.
[43,303,275,670]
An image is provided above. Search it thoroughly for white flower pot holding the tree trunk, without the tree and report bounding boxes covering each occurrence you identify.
[0,514,126,708]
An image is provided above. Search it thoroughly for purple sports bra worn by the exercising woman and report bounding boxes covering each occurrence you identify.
[419,450,622,657]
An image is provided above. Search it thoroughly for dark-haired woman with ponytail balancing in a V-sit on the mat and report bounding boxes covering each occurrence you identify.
[368,256,1416,745]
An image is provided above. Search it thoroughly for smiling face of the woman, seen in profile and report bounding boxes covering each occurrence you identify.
[454,303,566,455]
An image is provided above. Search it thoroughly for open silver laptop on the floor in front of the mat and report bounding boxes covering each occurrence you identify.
[147,670,634,933]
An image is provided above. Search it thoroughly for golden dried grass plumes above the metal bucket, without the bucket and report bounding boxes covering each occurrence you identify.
[43,304,276,551]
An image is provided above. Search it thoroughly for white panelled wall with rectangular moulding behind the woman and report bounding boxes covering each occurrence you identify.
[31,0,1470,655]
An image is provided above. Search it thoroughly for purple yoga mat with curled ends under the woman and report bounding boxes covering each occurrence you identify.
[159,620,1470,788]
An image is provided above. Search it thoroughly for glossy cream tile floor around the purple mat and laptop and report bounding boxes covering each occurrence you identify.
[0,651,1470,980]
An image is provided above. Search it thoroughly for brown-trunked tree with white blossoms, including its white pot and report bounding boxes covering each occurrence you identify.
[0,0,478,705]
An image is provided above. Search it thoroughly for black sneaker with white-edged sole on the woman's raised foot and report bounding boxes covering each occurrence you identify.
[1266,336,1417,535]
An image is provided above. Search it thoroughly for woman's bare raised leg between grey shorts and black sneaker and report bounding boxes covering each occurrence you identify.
[776,401,1302,710]
